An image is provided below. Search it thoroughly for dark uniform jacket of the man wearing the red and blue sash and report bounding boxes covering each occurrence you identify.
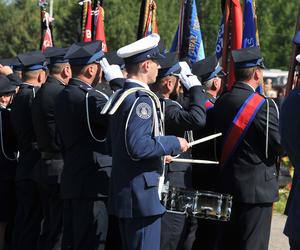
[213,82,283,204]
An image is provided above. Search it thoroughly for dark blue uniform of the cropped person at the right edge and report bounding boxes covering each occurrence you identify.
[280,86,300,250]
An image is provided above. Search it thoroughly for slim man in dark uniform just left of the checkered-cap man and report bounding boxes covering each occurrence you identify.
[32,47,72,249]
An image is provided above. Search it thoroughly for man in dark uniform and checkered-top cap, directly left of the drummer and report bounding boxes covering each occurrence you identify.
[55,41,111,250]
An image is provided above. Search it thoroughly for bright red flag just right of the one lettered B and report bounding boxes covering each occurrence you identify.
[94,1,107,52]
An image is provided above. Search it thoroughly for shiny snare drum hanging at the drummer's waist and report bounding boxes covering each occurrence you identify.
[162,187,232,221]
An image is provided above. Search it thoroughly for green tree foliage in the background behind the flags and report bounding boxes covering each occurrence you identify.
[0,0,299,69]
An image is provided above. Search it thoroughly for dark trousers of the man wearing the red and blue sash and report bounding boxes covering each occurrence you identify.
[217,202,272,250]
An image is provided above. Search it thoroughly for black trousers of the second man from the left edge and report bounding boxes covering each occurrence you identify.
[13,180,42,250]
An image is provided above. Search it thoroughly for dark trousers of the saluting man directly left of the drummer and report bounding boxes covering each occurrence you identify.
[62,198,108,250]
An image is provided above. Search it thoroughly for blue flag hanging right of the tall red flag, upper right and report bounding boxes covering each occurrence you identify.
[242,0,257,48]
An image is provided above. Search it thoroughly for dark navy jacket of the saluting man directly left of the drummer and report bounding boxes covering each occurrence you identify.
[54,78,111,199]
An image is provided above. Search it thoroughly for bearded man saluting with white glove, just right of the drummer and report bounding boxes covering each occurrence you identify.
[154,53,206,250]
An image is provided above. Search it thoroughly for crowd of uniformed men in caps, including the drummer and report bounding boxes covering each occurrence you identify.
[0,31,296,250]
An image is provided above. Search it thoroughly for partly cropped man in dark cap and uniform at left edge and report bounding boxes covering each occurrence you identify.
[0,75,17,250]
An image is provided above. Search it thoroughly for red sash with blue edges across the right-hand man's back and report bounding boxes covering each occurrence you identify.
[220,93,265,167]
